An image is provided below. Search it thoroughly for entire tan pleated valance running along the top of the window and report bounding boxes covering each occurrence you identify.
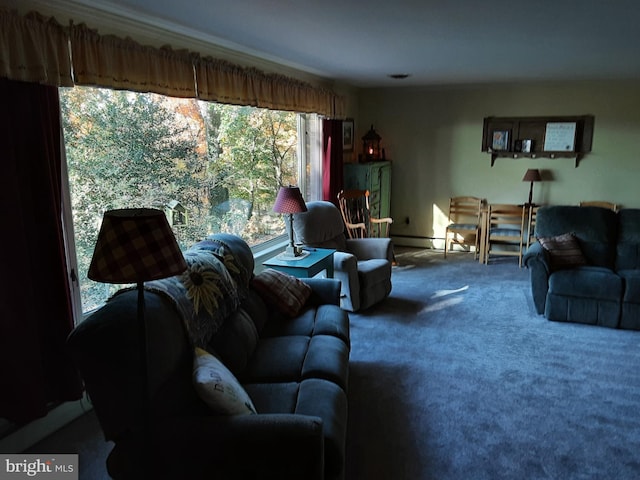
[0,10,344,117]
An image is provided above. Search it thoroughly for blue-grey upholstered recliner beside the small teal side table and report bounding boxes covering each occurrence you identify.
[293,201,393,312]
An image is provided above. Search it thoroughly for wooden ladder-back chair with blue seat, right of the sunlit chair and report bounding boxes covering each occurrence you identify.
[484,204,526,265]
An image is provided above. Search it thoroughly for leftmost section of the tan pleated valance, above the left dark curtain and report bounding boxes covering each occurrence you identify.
[0,10,73,87]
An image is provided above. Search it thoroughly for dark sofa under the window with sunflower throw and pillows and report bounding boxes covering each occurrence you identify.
[67,234,350,480]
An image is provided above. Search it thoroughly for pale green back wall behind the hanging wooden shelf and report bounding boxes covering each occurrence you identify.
[355,81,640,247]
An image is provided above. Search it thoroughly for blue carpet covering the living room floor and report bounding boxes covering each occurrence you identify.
[347,250,640,480]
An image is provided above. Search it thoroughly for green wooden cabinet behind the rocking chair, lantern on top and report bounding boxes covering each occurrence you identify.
[344,160,391,218]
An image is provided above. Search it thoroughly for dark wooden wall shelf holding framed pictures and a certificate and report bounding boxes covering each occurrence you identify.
[482,115,594,167]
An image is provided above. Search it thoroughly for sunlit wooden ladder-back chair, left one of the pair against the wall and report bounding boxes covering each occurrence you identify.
[444,197,483,260]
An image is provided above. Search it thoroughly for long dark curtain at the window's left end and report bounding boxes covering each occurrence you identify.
[0,79,82,424]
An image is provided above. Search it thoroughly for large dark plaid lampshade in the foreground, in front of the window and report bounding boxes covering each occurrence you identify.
[87,208,187,283]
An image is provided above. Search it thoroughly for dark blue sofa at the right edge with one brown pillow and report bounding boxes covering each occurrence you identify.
[524,206,640,330]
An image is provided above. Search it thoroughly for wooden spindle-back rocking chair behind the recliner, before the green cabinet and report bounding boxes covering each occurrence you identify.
[338,190,393,238]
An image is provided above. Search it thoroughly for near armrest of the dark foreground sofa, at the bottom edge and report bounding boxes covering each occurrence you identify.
[107,414,324,480]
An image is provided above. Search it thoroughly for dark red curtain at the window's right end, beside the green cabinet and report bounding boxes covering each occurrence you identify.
[322,120,344,206]
